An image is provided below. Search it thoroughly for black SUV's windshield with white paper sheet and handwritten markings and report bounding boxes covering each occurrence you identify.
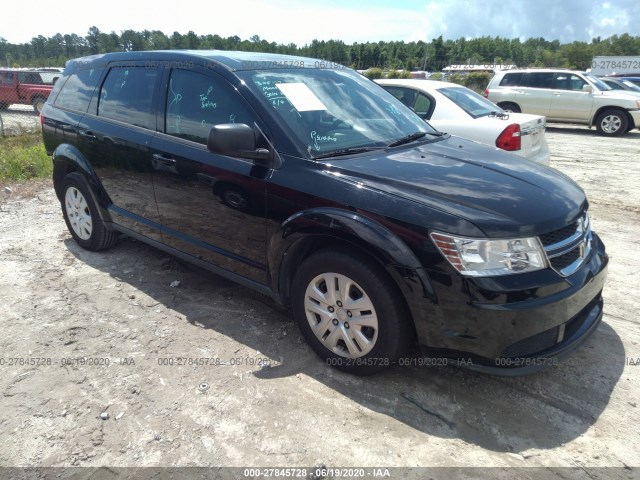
[242,69,437,157]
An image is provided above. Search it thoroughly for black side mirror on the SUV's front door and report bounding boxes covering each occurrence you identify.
[207,123,271,161]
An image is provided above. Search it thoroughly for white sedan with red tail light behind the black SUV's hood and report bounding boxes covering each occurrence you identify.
[376,79,550,165]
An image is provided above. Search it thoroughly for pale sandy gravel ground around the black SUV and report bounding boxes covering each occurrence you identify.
[0,122,640,479]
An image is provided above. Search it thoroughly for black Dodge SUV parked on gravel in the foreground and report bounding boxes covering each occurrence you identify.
[41,51,608,374]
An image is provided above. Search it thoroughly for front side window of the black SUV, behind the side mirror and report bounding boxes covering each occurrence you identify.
[165,69,253,144]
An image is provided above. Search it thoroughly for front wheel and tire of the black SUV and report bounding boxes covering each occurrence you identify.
[291,250,413,375]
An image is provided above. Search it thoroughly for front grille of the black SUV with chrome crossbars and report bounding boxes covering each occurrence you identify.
[540,213,592,277]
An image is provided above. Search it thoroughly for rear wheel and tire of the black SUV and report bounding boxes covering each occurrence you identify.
[61,172,118,252]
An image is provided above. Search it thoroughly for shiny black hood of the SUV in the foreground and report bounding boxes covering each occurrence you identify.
[321,137,588,237]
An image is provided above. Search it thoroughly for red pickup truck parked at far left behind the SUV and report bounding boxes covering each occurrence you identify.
[0,69,62,113]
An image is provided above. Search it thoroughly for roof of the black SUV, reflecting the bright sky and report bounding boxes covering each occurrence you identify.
[67,50,336,71]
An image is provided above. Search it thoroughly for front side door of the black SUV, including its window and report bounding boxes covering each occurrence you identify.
[151,67,270,283]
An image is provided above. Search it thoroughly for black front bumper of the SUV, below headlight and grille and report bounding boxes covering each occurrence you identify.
[418,234,608,375]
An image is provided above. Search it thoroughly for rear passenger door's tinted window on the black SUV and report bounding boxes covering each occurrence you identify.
[100,67,158,128]
